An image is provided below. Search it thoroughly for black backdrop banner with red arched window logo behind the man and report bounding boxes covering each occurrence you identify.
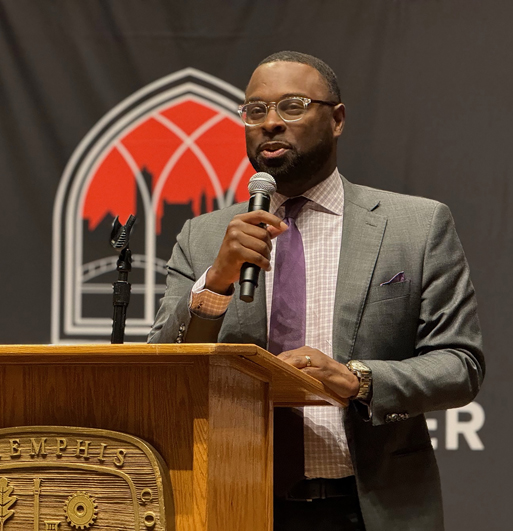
[0,0,513,531]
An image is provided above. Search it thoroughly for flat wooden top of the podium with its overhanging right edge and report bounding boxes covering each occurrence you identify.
[0,343,348,407]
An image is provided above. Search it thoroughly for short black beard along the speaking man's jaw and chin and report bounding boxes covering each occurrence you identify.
[248,132,333,195]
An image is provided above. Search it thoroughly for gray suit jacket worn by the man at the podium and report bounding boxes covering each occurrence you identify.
[150,179,485,531]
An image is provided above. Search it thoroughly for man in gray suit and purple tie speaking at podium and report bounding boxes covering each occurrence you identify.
[150,52,484,531]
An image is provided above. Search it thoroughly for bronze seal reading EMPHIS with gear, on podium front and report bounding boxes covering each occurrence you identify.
[0,426,174,531]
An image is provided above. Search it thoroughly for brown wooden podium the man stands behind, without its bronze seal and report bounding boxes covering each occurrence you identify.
[0,344,345,531]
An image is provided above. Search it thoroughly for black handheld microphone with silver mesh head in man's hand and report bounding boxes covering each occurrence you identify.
[239,171,276,302]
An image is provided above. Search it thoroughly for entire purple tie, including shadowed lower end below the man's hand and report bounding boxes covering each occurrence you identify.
[269,197,308,496]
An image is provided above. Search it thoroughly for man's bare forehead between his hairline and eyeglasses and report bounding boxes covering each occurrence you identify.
[246,61,328,100]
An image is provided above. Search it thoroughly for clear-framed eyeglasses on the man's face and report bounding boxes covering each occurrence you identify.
[239,96,338,126]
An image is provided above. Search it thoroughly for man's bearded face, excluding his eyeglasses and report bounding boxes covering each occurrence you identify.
[246,61,344,196]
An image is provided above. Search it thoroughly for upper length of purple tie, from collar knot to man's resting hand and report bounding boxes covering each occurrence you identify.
[269,197,308,354]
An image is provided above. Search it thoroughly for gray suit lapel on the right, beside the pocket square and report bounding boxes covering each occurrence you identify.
[333,179,387,363]
